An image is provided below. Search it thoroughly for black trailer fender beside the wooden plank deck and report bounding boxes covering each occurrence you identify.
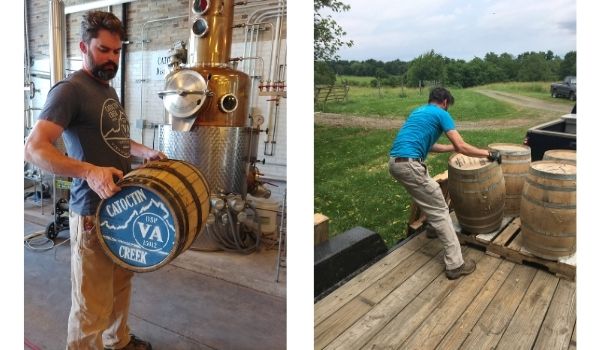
[314,226,387,297]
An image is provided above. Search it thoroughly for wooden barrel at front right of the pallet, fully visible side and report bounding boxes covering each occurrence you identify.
[521,160,577,260]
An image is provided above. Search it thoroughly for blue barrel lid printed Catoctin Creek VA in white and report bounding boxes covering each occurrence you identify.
[96,184,179,272]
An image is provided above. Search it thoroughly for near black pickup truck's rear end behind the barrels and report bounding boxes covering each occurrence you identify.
[523,114,577,162]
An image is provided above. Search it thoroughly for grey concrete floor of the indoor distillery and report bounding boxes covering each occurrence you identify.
[24,196,286,350]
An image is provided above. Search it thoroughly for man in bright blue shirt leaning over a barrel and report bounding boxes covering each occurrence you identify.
[389,87,502,279]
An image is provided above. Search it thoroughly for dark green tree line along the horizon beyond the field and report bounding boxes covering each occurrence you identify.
[314,50,577,88]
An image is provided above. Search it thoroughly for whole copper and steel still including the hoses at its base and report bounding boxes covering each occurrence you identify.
[158,0,270,252]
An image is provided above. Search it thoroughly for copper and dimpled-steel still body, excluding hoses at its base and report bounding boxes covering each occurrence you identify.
[159,0,258,197]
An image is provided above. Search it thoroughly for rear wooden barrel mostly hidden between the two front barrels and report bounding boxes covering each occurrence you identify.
[488,143,531,216]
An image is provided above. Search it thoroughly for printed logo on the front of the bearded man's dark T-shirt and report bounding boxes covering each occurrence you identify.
[100,98,131,158]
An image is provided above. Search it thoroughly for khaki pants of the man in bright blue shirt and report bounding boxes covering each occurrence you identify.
[388,158,464,270]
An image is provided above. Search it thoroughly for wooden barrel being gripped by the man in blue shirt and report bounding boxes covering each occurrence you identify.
[448,154,505,234]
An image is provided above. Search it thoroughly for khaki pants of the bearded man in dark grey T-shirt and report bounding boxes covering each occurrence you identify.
[67,212,133,350]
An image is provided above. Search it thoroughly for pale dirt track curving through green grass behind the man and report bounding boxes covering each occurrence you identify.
[315,89,571,130]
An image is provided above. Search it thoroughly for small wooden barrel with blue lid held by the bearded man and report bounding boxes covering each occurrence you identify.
[96,159,210,272]
